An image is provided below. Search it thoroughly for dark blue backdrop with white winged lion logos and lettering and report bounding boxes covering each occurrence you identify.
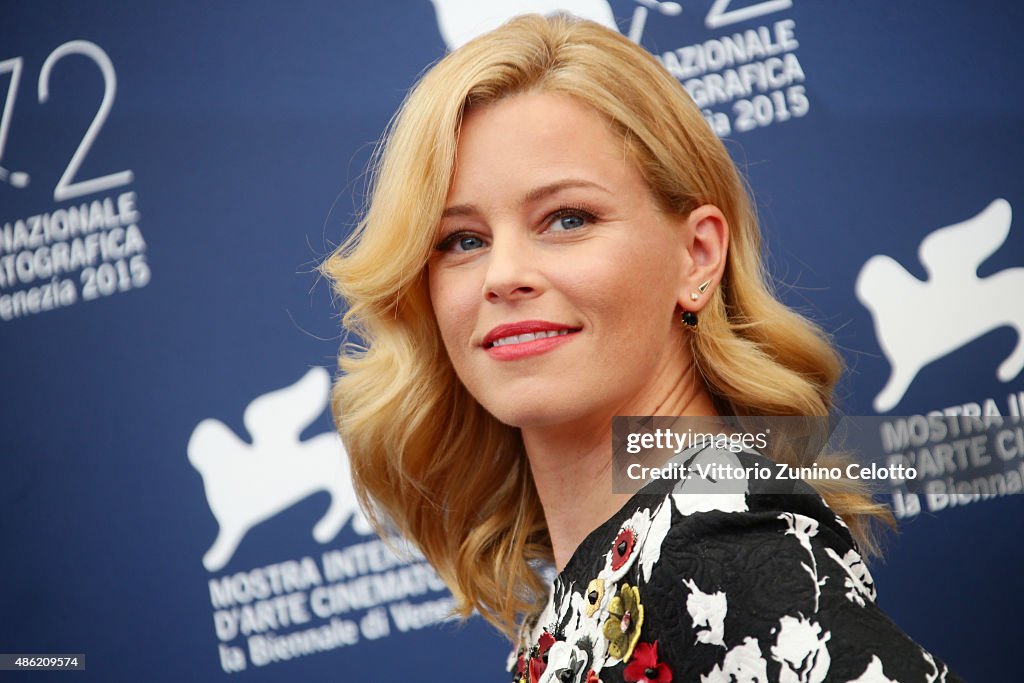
[0,0,1024,682]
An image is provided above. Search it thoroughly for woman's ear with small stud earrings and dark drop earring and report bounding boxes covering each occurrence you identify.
[679,204,729,313]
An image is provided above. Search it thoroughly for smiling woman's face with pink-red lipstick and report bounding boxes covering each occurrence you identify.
[428,92,690,428]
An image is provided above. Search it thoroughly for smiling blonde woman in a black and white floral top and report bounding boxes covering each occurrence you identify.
[324,15,956,683]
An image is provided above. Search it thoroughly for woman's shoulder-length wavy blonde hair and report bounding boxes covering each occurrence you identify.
[322,15,893,636]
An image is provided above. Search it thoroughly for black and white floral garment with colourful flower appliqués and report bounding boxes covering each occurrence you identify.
[509,451,961,683]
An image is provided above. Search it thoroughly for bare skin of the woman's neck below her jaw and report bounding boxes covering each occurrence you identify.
[522,364,715,571]
